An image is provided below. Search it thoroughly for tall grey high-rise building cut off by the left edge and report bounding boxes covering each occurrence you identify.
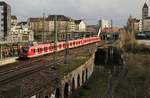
[0,1,11,40]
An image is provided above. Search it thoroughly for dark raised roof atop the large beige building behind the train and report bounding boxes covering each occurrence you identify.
[46,15,70,21]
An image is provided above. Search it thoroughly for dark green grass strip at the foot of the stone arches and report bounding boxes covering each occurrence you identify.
[73,69,109,98]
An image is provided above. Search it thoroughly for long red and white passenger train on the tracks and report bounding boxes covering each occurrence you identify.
[19,37,100,58]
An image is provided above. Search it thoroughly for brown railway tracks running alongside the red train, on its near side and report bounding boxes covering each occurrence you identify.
[0,44,96,85]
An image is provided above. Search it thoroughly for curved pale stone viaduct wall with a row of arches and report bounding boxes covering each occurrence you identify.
[26,53,95,98]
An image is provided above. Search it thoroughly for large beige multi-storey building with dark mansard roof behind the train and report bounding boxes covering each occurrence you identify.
[28,15,75,42]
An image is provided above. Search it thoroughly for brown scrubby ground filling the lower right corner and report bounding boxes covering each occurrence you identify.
[114,53,150,98]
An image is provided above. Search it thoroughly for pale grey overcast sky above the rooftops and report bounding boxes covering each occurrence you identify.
[4,0,150,26]
